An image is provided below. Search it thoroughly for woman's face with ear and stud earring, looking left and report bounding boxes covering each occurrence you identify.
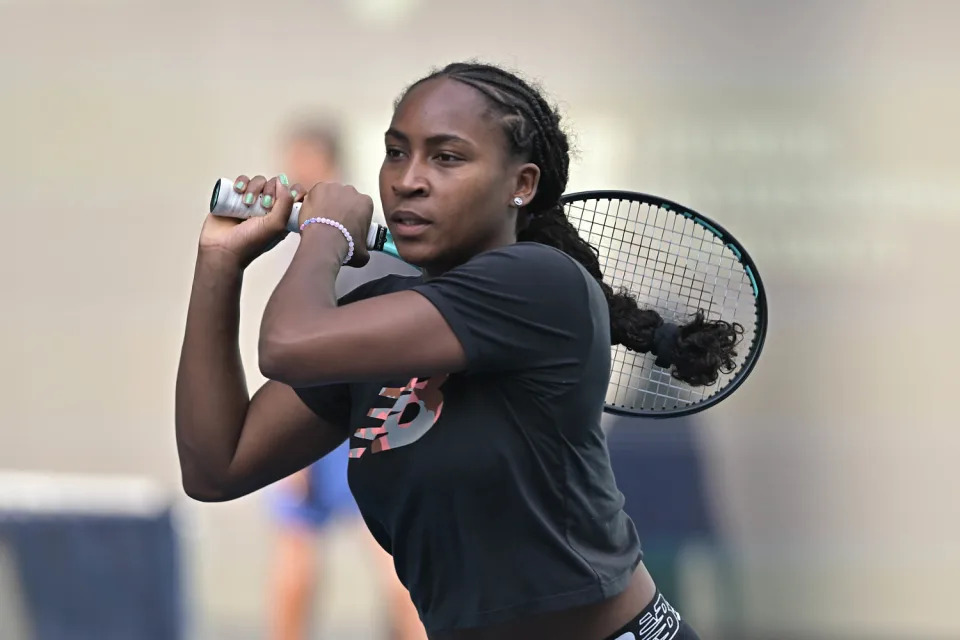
[380,77,540,275]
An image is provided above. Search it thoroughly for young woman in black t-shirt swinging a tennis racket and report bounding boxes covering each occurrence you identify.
[177,64,737,640]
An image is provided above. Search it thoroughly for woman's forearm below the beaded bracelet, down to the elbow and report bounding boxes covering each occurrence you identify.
[259,225,346,381]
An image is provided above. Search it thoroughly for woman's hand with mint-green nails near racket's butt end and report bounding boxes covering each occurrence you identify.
[200,175,304,268]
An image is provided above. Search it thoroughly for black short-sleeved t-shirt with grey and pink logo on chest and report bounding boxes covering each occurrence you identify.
[298,242,641,632]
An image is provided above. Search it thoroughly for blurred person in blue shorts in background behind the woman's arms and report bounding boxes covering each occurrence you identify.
[267,116,426,640]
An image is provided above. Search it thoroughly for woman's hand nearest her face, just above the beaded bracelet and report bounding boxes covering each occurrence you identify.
[299,182,373,267]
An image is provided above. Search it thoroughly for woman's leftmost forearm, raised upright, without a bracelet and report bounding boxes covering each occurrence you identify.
[176,252,250,492]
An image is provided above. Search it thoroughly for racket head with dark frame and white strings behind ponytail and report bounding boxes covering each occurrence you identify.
[561,191,767,418]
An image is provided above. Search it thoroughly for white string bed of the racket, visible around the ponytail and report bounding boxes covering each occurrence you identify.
[566,199,757,410]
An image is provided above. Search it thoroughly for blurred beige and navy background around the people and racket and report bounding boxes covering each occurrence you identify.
[0,0,960,640]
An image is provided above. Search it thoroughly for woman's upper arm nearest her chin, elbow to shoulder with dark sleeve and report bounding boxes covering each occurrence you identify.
[261,245,592,386]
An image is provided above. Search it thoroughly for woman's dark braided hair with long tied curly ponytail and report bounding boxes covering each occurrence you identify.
[401,63,743,385]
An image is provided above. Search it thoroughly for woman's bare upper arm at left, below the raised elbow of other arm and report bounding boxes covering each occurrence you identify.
[210,381,348,500]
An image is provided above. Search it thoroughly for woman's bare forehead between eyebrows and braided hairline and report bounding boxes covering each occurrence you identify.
[391,78,503,144]
